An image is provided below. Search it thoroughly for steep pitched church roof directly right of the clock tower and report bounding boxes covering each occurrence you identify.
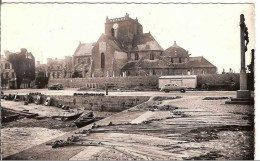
[133,33,163,51]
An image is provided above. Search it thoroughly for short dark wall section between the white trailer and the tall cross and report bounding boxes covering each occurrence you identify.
[197,73,239,88]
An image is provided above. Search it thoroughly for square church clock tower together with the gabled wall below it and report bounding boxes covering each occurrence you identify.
[91,14,146,77]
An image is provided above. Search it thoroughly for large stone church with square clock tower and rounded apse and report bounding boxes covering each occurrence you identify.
[73,14,217,77]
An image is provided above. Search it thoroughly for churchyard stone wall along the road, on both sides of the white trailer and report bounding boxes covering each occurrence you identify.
[48,73,239,90]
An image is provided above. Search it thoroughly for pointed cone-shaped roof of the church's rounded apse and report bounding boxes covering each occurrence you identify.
[163,41,189,58]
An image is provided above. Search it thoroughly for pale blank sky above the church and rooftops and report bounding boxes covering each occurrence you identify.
[1,4,255,72]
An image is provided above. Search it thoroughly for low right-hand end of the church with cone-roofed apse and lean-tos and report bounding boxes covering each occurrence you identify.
[122,41,217,76]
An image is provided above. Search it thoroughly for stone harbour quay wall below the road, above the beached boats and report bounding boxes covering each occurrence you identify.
[19,95,150,112]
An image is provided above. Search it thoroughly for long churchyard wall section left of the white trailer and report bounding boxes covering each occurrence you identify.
[48,76,159,89]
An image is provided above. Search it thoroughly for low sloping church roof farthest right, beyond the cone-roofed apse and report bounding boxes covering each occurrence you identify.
[187,56,216,68]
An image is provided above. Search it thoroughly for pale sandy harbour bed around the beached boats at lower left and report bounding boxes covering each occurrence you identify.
[1,100,114,157]
